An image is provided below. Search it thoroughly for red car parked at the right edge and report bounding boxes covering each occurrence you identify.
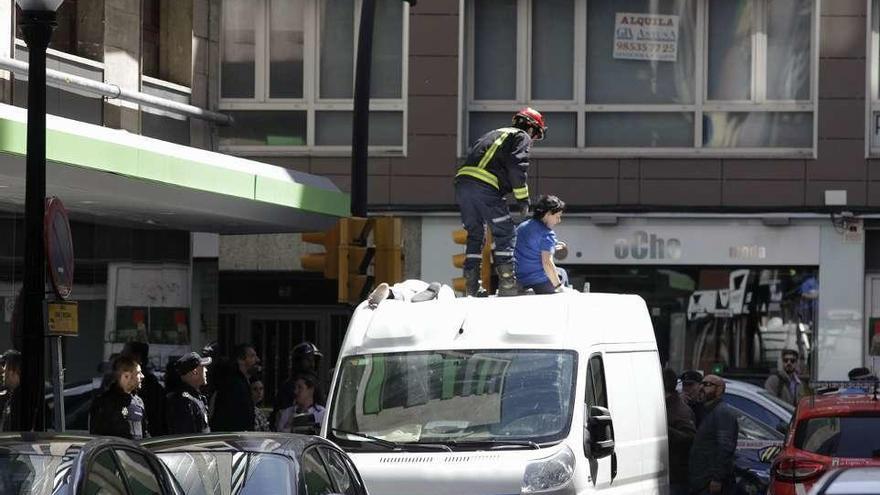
[768,390,880,495]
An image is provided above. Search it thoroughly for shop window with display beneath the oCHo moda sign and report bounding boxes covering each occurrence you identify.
[564,265,820,376]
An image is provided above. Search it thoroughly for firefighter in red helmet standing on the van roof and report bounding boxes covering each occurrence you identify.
[455,107,547,296]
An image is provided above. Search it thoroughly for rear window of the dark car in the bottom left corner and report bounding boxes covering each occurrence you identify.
[0,452,70,495]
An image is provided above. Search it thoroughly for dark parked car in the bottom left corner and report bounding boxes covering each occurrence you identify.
[0,432,184,495]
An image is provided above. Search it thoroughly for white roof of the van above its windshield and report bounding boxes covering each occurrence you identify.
[341,291,657,355]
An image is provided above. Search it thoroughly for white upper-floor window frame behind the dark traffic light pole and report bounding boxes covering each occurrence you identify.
[217,0,410,157]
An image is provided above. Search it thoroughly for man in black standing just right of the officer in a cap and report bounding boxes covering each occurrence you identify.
[211,344,260,431]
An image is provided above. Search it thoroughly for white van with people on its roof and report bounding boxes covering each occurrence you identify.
[322,292,668,495]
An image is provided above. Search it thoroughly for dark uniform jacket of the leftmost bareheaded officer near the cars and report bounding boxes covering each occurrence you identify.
[89,383,146,440]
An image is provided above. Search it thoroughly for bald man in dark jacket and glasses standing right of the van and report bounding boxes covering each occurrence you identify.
[688,375,739,495]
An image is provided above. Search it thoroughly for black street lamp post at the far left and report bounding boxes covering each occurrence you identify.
[15,0,64,431]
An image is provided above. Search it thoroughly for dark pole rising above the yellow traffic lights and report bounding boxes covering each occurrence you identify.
[351,0,416,218]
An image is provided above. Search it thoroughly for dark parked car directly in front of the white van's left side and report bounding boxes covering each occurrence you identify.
[141,432,367,495]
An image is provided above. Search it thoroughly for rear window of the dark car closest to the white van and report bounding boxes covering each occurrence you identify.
[157,451,297,495]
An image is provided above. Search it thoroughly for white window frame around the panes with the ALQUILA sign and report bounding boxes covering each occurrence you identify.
[457,0,820,159]
